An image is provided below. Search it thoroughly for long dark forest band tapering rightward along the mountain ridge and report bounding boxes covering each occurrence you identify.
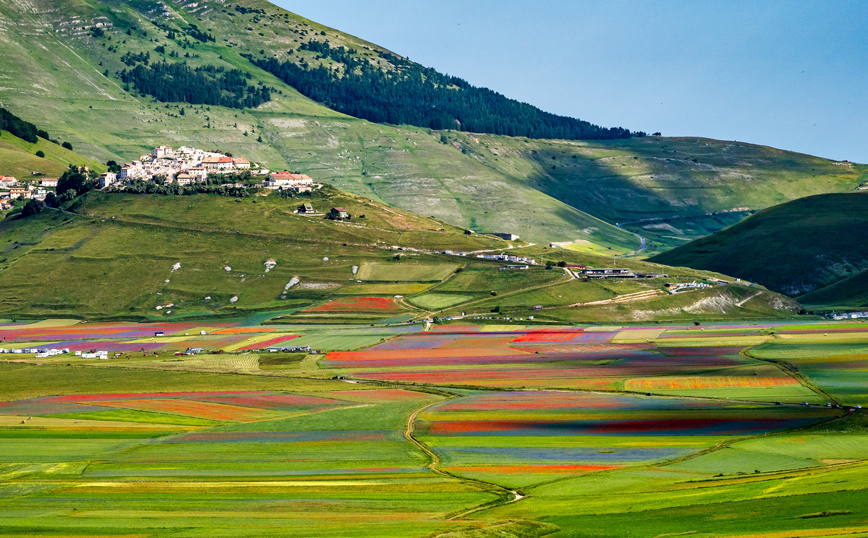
[246,42,644,140]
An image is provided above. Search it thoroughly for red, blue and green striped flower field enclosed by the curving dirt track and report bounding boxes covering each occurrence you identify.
[417,391,834,487]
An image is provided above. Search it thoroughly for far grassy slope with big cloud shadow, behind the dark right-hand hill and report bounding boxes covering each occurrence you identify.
[452,134,868,252]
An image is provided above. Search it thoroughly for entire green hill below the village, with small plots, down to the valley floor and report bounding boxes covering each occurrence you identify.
[0,187,798,324]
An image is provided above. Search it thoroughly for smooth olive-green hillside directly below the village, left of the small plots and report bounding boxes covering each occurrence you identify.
[0,191,505,317]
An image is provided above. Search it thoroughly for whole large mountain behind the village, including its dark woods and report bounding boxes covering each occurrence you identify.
[0,0,868,247]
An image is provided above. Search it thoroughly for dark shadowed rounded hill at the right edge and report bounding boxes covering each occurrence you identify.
[651,192,868,305]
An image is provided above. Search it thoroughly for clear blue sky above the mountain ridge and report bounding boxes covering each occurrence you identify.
[272,0,868,163]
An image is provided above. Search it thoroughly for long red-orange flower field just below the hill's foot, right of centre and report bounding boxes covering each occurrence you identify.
[323,326,821,403]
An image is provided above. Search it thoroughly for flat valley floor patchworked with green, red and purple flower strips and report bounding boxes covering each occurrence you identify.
[0,319,868,538]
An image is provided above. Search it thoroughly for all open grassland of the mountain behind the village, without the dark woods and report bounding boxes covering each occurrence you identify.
[0,0,864,248]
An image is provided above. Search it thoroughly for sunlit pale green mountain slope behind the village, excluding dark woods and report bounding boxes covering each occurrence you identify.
[0,0,636,247]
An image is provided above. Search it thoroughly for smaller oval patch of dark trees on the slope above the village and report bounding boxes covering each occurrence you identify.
[120,62,271,108]
